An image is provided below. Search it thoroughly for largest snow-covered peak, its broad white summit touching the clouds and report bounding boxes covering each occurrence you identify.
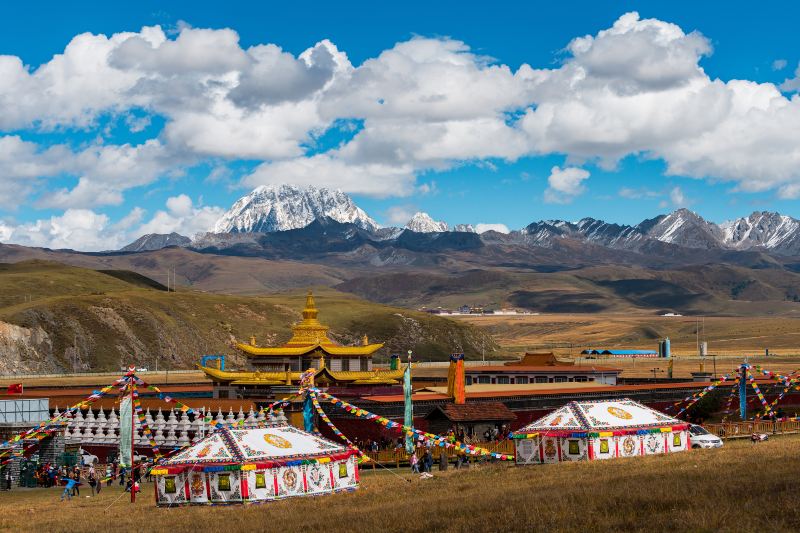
[212,185,379,233]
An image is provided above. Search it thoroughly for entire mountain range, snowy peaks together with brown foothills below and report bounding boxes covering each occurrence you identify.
[0,186,800,316]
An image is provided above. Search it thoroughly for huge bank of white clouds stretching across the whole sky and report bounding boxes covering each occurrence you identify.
[6,13,800,226]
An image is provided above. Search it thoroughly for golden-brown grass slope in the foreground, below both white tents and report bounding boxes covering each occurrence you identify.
[0,437,800,532]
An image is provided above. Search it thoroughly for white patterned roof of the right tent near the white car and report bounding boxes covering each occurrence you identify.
[517,398,686,433]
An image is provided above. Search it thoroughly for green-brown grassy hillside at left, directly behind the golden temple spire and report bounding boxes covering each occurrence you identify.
[0,261,493,371]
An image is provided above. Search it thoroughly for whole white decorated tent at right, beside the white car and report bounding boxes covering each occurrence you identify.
[514,398,691,465]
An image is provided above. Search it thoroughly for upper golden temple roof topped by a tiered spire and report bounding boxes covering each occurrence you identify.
[236,291,383,356]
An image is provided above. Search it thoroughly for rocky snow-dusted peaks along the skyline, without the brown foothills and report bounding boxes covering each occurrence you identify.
[122,185,800,256]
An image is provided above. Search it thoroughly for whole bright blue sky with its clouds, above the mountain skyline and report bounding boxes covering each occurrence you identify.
[0,1,800,249]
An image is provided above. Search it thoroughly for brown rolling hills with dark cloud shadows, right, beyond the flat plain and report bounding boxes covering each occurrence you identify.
[336,265,800,316]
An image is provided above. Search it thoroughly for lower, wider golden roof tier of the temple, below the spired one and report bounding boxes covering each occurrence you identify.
[197,365,403,385]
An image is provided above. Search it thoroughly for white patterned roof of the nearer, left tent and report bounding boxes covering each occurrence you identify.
[164,424,348,465]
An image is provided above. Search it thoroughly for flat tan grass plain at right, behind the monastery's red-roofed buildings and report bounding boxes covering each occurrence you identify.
[457,313,800,378]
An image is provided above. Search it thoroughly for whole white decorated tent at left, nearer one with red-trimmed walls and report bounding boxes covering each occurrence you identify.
[153,425,359,506]
